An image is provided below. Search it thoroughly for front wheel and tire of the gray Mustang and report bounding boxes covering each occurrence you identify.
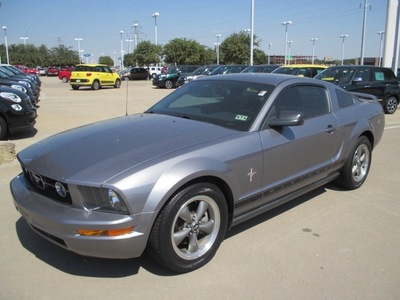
[147,183,228,273]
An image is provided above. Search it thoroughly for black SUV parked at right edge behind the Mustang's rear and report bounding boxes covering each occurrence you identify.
[314,66,400,114]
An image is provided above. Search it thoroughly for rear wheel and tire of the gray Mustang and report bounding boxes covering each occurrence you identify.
[339,136,372,190]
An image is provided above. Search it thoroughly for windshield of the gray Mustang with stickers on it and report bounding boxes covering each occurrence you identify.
[146,80,274,131]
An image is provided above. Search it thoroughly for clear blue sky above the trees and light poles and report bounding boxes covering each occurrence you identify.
[0,0,388,62]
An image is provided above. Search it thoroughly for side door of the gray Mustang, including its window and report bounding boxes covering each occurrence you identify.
[260,85,340,202]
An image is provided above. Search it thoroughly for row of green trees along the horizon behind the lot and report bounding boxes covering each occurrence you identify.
[0,32,350,67]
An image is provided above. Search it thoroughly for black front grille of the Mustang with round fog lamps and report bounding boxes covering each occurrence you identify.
[23,168,72,205]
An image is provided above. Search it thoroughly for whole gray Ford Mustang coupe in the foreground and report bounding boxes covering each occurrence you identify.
[10,74,385,273]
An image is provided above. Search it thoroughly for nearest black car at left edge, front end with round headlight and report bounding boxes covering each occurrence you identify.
[0,86,37,140]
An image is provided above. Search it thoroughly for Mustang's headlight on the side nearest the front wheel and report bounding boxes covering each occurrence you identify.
[79,187,129,214]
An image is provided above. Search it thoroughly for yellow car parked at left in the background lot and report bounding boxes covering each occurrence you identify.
[70,64,121,90]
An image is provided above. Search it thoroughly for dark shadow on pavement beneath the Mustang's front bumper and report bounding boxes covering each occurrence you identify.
[16,217,174,278]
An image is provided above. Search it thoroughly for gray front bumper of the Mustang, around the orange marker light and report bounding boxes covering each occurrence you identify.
[10,173,153,259]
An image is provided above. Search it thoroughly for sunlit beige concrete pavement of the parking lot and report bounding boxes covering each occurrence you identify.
[0,77,400,300]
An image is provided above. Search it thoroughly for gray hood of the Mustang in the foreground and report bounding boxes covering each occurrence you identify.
[18,114,236,185]
